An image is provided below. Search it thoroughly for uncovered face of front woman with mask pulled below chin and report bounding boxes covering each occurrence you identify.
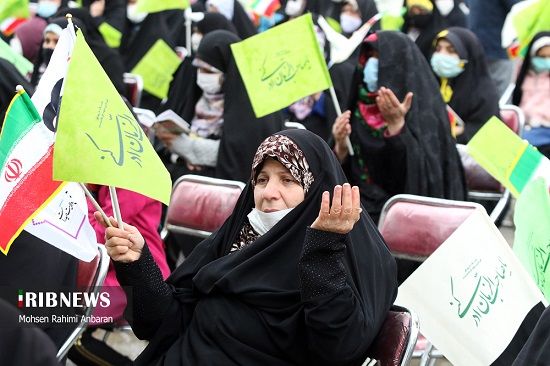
[254,158,304,212]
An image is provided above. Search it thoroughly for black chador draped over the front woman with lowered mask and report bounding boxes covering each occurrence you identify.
[117,130,397,366]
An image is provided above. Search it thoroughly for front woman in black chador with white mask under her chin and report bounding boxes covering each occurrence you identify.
[95,130,397,365]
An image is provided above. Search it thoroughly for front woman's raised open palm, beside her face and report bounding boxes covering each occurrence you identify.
[311,183,361,234]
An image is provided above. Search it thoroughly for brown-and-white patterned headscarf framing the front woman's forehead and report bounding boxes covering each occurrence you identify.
[252,135,314,194]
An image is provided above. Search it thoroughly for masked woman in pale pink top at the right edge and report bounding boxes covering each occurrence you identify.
[512,32,550,158]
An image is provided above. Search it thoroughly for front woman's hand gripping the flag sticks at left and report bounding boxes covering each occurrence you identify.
[94,211,145,263]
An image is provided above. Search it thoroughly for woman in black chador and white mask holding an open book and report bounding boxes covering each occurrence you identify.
[157,30,283,182]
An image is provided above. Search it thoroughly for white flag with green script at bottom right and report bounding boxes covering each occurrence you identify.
[396,210,545,366]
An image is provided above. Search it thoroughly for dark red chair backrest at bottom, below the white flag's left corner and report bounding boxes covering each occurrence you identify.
[368,305,419,366]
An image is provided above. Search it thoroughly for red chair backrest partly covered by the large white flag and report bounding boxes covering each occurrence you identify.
[378,194,483,261]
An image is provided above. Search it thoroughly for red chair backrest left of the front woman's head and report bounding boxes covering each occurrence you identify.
[162,174,245,238]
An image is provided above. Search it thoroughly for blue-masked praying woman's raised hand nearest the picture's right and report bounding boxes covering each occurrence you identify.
[376,87,413,135]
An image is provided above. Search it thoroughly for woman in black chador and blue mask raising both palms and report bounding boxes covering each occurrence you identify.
[333,31,466,221]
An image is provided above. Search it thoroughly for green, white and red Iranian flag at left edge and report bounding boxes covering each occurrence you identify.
[0,90,65,254]
